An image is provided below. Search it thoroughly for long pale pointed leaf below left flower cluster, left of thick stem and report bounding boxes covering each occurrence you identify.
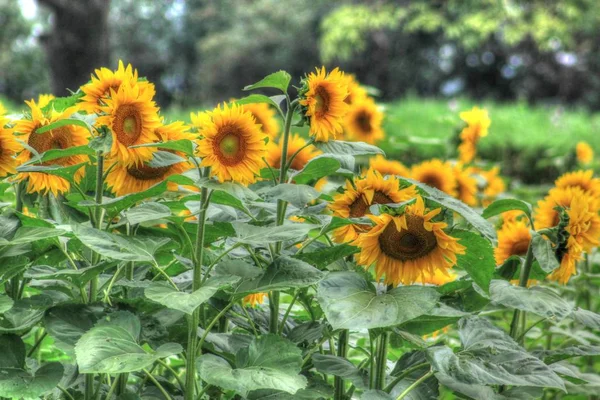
[73,225,170,261]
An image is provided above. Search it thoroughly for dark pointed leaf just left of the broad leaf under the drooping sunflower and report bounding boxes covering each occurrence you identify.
[236,256,323,293]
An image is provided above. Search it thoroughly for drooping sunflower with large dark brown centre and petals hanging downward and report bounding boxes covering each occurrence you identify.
[353,196,465,286]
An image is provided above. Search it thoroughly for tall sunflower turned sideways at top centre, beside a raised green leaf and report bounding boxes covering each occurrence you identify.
[300,67,349,142]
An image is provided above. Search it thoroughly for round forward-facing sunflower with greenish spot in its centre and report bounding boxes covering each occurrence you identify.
[191,104,266,184]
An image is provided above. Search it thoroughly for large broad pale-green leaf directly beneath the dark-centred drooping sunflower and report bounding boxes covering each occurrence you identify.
[317,272,439,329]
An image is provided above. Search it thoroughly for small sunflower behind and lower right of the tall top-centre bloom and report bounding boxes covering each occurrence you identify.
[344,97,385,144]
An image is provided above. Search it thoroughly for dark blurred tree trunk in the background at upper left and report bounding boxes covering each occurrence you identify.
[38,0,110,96]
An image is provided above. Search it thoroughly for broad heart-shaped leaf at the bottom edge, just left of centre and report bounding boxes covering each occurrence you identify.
[197,335,307,397]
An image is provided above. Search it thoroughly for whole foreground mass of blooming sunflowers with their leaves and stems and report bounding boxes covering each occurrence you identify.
[0,62,600,400]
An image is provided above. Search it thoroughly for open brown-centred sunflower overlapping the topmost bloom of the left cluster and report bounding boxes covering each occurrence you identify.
[96,85,160,166]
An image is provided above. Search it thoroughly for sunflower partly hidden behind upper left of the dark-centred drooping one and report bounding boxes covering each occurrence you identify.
[329,169,417,243]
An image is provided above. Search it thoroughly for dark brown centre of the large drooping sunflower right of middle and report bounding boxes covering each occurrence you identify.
[379,214,437,261]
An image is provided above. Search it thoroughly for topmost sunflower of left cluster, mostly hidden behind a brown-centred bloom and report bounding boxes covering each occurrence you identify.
[80,60,155,114]
